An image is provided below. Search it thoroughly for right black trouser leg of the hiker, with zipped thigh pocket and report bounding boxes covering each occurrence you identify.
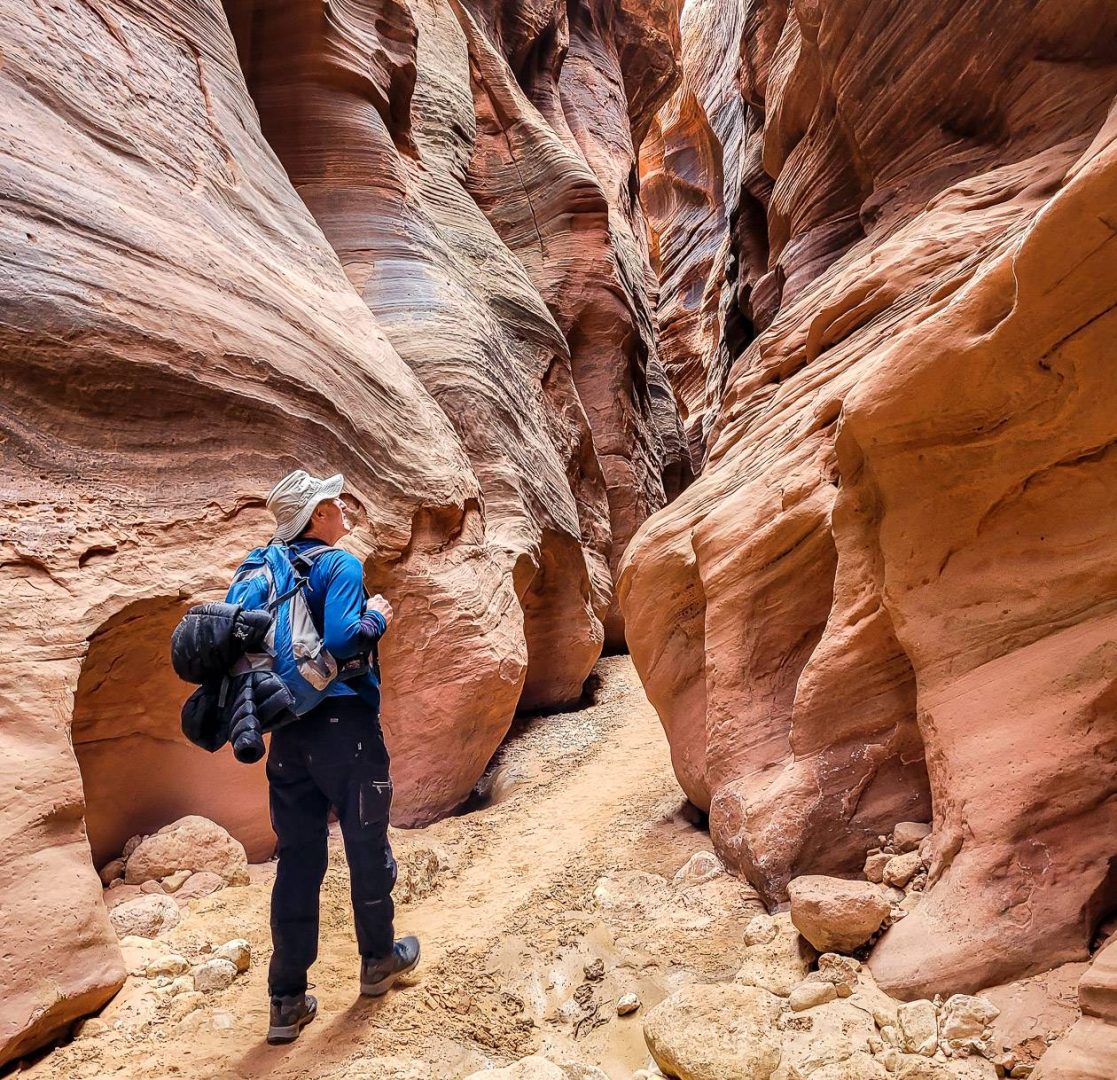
[311,697,395,959]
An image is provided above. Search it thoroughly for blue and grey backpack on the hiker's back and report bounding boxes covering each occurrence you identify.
[226,543,337,716]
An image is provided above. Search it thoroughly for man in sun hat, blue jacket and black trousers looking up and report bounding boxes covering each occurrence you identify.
[226,469,419,1043]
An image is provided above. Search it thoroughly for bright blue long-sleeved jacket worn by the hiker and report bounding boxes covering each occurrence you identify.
[226,538,388,715]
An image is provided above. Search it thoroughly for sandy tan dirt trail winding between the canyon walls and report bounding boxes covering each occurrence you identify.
[28,658,758,1080]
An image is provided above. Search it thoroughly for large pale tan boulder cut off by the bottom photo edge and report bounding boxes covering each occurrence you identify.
[643,984,781,1080]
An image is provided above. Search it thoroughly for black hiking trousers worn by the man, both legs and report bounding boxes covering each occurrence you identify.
[267,697,395,997]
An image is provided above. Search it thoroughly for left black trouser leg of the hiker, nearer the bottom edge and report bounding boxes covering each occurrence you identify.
[267,720,330,996]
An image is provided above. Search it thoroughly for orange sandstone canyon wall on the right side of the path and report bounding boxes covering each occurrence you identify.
[619,0,1117,996]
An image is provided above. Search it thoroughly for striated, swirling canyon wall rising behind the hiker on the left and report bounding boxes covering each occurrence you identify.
[0,0,689,1062]
